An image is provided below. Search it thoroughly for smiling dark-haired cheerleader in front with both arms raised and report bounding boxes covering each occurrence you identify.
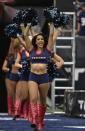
[19,23,58,130]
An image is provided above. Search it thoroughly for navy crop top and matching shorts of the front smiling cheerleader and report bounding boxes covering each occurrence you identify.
[29,48,51,84]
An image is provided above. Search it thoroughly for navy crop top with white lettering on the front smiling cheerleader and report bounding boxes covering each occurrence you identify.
[30,48,51,64]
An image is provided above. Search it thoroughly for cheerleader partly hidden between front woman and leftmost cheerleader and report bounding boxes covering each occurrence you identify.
[15,47,30,118]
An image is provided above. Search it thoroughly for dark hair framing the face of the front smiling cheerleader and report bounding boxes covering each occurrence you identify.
[32,33,48,49]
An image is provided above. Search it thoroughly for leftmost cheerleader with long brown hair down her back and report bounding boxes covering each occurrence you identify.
[2,38,19,116]
